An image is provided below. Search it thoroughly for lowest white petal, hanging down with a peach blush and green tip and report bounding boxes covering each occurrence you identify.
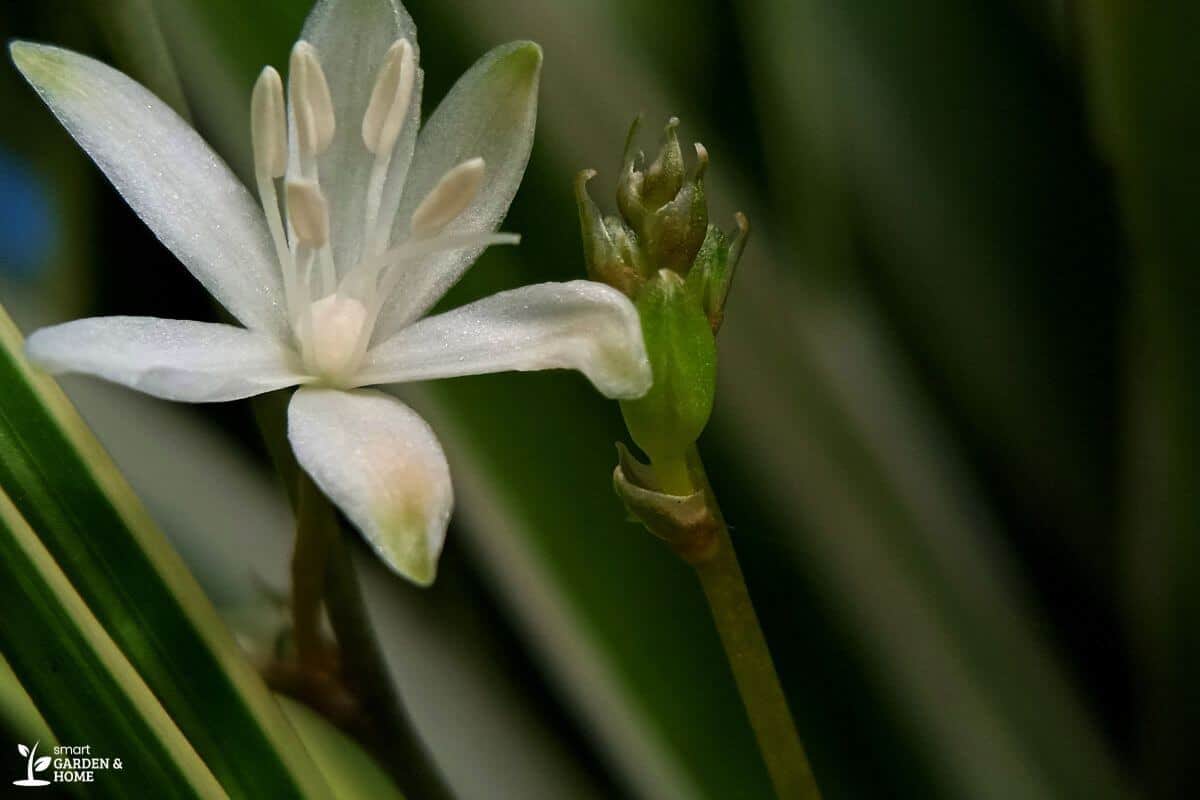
[288,389,454,587]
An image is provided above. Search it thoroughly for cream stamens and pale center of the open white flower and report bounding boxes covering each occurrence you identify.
[251,40,516,386]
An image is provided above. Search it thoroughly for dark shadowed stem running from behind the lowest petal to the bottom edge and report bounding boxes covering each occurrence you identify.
[314,477,454,800]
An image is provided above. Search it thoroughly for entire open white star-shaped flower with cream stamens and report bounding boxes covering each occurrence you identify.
[12,0,650,584]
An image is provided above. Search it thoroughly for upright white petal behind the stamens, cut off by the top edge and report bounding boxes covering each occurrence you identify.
[292,0,422,273]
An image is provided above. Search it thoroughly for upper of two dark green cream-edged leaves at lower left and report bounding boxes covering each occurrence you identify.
[0,303,329,798]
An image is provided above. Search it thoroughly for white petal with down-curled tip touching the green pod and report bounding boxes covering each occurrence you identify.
[355,281,650,397]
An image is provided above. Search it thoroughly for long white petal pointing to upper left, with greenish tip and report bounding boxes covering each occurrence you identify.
[12,42,288,341]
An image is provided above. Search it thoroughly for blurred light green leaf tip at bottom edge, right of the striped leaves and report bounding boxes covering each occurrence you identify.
[275,694,403,800]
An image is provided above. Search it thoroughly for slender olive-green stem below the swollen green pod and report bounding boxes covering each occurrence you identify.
[676,445,821,800]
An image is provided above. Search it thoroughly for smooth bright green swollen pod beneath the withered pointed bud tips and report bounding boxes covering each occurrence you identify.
[620,270,716,463]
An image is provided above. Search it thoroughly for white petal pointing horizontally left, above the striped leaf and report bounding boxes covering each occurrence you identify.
[25,317,306,403]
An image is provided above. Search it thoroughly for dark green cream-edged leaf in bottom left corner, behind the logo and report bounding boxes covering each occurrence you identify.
[0,484,224,798]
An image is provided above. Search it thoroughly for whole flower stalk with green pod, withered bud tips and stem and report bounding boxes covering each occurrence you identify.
[575,119,821,800]
